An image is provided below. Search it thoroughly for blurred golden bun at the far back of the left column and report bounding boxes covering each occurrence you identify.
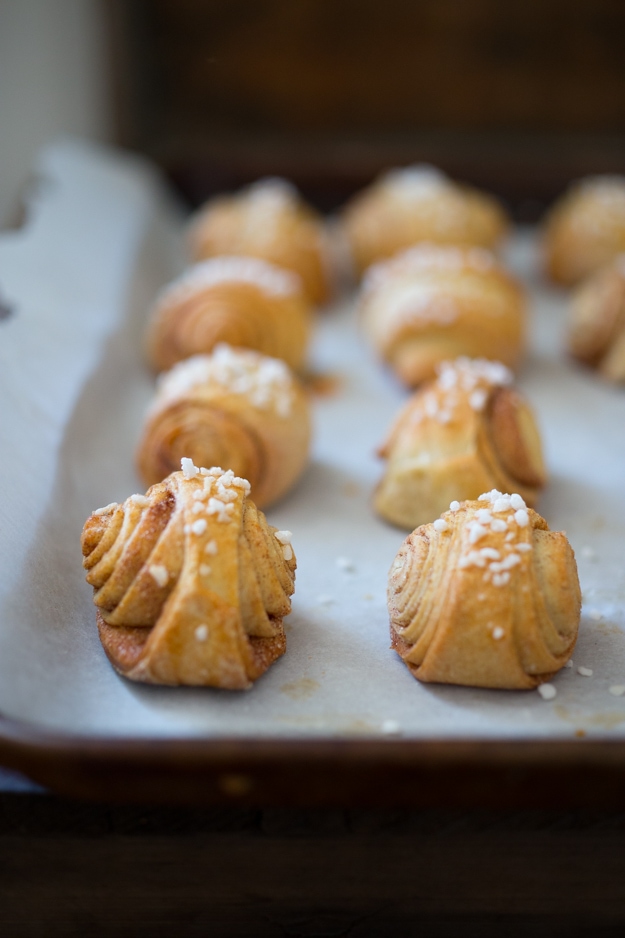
[189,178,330,303]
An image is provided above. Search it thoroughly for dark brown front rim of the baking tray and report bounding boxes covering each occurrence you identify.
[0,718,625,808]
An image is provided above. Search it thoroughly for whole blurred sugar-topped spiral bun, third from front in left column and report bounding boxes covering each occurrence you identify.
[148,257,311,371]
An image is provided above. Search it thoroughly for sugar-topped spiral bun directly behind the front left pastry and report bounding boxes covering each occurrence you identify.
[137,345,310,507]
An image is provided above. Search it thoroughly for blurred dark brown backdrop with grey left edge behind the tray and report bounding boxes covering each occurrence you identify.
[0,0,625,224]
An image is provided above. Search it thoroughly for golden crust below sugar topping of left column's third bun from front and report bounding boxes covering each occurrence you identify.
[147,266,311,371]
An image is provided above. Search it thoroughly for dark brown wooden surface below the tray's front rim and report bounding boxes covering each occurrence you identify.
[0,770,625,938]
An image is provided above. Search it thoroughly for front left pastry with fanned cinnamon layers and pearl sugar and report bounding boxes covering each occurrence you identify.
[82,460,296,690]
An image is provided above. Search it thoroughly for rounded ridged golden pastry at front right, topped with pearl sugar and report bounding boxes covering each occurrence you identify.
[388,491,581,690]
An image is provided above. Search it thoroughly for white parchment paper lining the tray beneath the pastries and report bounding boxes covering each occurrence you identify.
[0,142,625,739]
